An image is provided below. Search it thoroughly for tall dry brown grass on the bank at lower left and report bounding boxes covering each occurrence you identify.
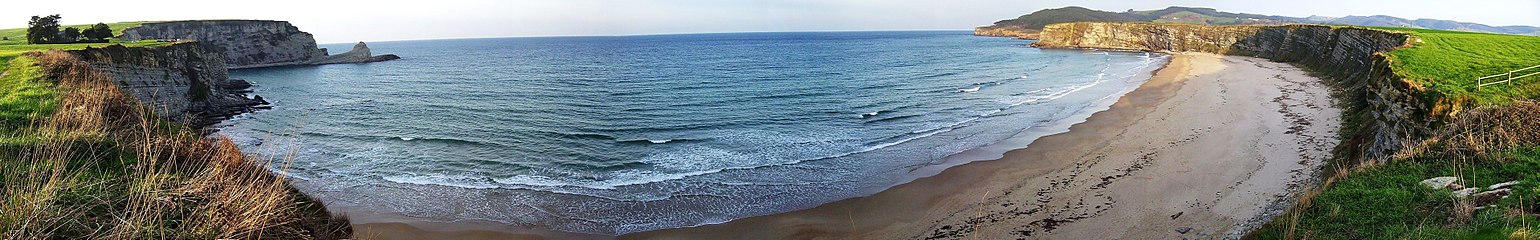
[0,51,351,238]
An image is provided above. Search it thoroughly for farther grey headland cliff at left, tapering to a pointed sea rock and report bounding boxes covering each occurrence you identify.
[122,20,399,69]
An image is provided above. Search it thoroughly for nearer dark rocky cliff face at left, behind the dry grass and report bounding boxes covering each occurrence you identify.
[68,43,266,128]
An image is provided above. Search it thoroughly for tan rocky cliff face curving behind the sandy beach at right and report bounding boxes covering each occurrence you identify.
[1032,23,1422,160]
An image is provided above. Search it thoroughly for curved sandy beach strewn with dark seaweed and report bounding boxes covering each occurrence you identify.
[356,54,1340,238]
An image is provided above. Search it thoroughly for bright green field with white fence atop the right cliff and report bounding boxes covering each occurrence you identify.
[1377,28,1540,105]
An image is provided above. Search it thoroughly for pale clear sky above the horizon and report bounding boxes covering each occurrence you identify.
[0,0,1540,43]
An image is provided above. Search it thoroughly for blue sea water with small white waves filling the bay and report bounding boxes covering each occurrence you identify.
[223,31,1164,234]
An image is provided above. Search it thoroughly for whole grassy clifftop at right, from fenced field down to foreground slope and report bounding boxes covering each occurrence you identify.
[1250,28,1540,238]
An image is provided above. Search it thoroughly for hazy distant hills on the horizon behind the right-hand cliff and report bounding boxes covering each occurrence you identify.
[975,6,1540,38]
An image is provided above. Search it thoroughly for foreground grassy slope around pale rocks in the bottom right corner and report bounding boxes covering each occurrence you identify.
[1252,149,1540,238]
